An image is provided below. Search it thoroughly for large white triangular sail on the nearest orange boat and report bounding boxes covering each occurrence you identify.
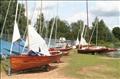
[28,25,50,56]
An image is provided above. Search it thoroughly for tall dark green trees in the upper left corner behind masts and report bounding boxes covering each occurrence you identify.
[0,0,27,41]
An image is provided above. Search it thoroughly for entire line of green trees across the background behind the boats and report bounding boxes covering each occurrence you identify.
[0,0,120,45]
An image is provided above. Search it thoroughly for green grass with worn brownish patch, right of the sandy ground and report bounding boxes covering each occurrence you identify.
[65,49,120,79]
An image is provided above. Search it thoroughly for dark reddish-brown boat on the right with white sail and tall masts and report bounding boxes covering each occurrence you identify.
[78,1,117,54]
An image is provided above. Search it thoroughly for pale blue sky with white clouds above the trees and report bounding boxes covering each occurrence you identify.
[20,1,120,29]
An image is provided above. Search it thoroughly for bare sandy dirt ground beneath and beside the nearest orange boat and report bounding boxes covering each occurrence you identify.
[1,58,76,79]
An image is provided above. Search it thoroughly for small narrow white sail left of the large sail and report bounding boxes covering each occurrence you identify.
[12,20,20,43]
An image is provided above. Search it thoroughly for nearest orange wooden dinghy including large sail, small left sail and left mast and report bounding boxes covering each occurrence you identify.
[8,3,61,75]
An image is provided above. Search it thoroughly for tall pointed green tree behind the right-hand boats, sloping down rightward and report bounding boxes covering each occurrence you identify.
[92,18,113,43]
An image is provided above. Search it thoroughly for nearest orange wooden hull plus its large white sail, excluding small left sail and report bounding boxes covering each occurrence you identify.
[10,23,61,72]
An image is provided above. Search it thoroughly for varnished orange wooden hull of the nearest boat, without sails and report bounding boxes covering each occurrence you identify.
[10,51,61,72]
